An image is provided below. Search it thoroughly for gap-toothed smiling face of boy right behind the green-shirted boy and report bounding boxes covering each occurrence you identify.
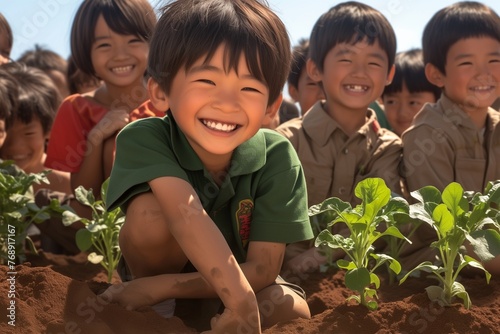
[307,41,394,112]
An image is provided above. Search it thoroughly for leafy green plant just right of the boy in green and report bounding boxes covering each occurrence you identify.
[309,178,409,310]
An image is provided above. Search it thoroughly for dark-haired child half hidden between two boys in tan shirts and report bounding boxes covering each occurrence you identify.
[382,49,441,136]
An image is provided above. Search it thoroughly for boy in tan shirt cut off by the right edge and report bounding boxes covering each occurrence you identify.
[403,1,500,274]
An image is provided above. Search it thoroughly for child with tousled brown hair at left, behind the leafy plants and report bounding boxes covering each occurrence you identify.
[0,63,80,255]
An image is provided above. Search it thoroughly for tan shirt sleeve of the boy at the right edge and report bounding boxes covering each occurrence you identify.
[402,125,455,191]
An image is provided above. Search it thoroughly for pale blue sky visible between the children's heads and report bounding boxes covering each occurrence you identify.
[0,0,500,59]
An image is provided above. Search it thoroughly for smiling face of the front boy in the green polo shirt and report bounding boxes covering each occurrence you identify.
[149,45,281,162]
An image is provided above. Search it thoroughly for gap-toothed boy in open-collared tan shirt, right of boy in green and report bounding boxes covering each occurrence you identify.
[276,1,402,272]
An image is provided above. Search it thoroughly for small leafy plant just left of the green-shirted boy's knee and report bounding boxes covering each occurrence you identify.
[65,179,125,282]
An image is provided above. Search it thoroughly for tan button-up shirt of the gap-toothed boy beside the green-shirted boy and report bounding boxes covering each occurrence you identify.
[276,101,402,205]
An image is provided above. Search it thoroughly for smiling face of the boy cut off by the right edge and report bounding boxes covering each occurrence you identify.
[426,37,500,112]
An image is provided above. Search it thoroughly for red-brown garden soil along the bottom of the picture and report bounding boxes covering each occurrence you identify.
[0,253,500,334]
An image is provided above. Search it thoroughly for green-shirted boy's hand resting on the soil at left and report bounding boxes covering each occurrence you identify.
[98,278,157,311]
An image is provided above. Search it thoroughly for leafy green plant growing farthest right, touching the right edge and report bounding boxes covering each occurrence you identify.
[400,182,500,309]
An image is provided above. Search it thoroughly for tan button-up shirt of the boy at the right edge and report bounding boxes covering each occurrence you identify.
[402,95,500,192]
